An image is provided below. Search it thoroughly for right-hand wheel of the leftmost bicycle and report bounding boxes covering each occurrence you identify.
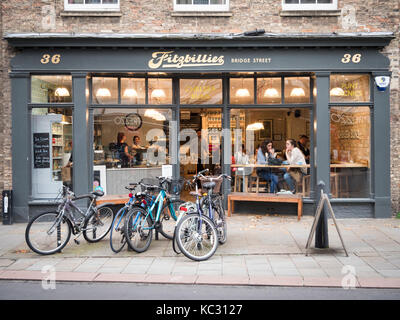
[83,207,114,242]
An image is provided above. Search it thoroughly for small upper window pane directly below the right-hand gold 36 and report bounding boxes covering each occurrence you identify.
[330,74,370,102]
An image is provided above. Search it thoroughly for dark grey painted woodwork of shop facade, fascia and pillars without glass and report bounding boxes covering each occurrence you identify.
[5,33,393,221]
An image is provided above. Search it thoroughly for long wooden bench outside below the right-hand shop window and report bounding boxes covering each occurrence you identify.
[228,192,303,220]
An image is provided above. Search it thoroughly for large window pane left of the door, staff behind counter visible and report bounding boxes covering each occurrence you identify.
[93,108,173,194]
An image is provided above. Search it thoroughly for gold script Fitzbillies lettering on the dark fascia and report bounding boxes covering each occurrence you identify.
[148,51,225,69]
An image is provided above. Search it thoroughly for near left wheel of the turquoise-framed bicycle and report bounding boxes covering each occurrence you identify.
[124,207,153,253]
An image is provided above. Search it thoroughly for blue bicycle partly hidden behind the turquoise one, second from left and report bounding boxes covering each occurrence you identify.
[110,183,154,253]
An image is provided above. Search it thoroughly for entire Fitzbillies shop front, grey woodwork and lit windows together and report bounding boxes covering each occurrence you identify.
[6,33,392,221]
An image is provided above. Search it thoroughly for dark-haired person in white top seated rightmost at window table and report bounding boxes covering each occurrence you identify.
[283,139,307,194]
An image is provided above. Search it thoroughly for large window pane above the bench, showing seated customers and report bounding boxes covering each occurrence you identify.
[230,108,311,197]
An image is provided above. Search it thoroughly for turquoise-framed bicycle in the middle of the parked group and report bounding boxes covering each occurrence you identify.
[125,177,183,253]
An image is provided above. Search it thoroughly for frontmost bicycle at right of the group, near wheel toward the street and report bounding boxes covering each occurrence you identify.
[174,169,219,261]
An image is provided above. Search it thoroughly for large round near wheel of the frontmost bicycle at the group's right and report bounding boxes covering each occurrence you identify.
[176,213,218,261]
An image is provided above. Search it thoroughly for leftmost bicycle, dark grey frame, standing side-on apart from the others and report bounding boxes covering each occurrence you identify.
[25,186,114,255]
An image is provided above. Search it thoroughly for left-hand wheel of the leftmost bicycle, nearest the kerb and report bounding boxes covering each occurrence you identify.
[25,211,72,255]
